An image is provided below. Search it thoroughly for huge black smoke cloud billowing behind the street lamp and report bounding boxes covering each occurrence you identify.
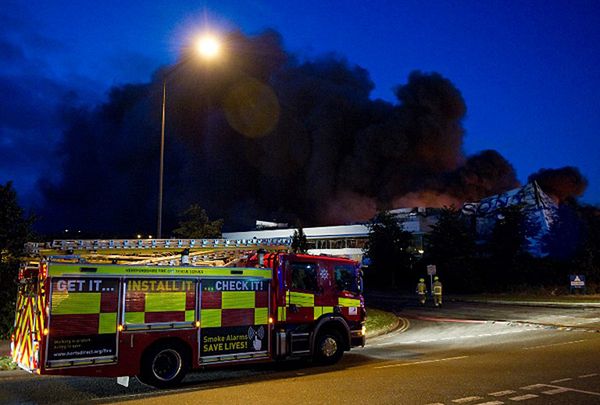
[35,31,552,236]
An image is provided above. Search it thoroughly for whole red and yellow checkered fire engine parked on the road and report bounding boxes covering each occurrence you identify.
[11,240,366,388]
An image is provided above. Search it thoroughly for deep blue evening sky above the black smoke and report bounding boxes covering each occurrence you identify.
[0,0,600,205]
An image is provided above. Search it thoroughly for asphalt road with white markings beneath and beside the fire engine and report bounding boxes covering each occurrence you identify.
[0,299,600,405]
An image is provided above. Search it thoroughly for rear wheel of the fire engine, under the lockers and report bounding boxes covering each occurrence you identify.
[138,344,189,388]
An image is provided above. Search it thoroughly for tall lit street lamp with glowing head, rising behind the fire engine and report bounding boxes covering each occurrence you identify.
[156,34,221,239]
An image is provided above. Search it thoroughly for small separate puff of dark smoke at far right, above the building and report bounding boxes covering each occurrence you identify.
[528,166,588,201]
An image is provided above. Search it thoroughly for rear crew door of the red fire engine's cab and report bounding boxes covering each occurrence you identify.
[286,262,319,323]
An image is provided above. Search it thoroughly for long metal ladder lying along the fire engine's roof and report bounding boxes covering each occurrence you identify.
[25,238,291,266]
